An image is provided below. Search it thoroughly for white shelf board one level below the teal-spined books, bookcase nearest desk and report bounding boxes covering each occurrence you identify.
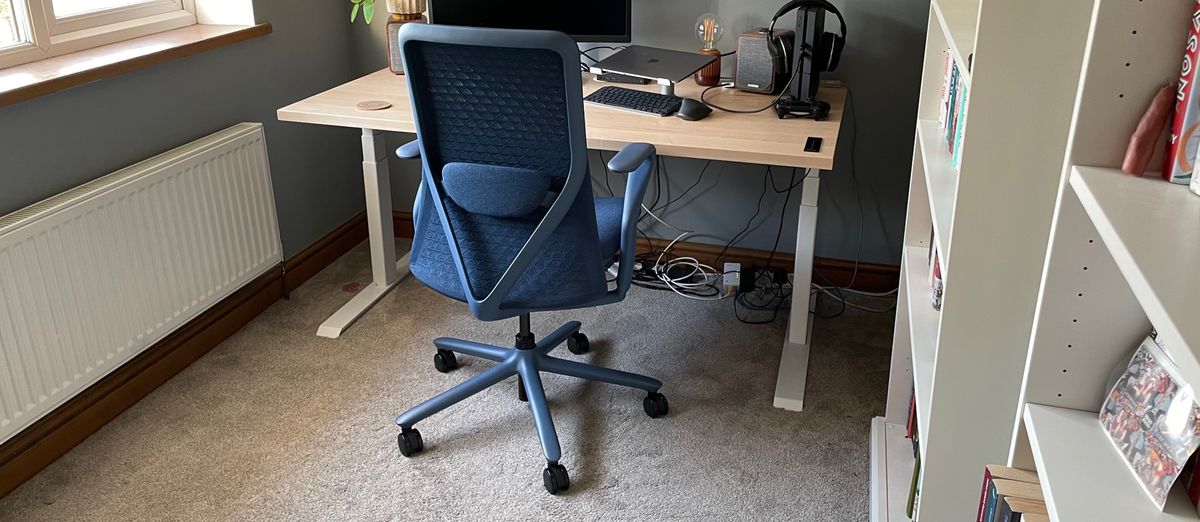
[904,246,941,455]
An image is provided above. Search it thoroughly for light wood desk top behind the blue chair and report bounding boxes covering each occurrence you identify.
[278,70,846,170]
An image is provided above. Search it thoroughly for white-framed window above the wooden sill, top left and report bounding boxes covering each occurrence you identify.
[0,0,196,68]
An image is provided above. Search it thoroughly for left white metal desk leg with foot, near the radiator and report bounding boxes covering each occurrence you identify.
[317,128,408,338]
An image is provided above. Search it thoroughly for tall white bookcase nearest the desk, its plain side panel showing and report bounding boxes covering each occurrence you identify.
[871,0,1094,522]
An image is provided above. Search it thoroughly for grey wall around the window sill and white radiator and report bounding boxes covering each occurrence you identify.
[0,0,364,256]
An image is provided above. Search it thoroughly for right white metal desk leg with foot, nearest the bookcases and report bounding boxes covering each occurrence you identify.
[775,169,821,412]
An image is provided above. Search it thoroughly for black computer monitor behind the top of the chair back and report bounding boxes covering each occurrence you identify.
[430,0,632,43]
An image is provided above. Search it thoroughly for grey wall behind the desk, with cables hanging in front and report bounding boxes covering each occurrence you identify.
[354,0,929,264]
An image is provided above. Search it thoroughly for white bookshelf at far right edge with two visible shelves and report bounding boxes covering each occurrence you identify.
[1008,0,1200,522]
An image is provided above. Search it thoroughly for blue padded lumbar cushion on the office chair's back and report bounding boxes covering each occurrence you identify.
[442,162,551,217]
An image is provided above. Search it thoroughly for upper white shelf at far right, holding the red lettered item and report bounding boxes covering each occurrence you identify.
[1070,167,1200,396]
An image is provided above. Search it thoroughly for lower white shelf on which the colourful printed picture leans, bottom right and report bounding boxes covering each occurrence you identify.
[1025,404,1200,522]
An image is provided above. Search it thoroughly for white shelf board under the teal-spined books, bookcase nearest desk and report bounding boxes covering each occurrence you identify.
[917,120,959,258]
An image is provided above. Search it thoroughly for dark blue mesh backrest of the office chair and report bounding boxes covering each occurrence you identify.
[404,41,607,314]
